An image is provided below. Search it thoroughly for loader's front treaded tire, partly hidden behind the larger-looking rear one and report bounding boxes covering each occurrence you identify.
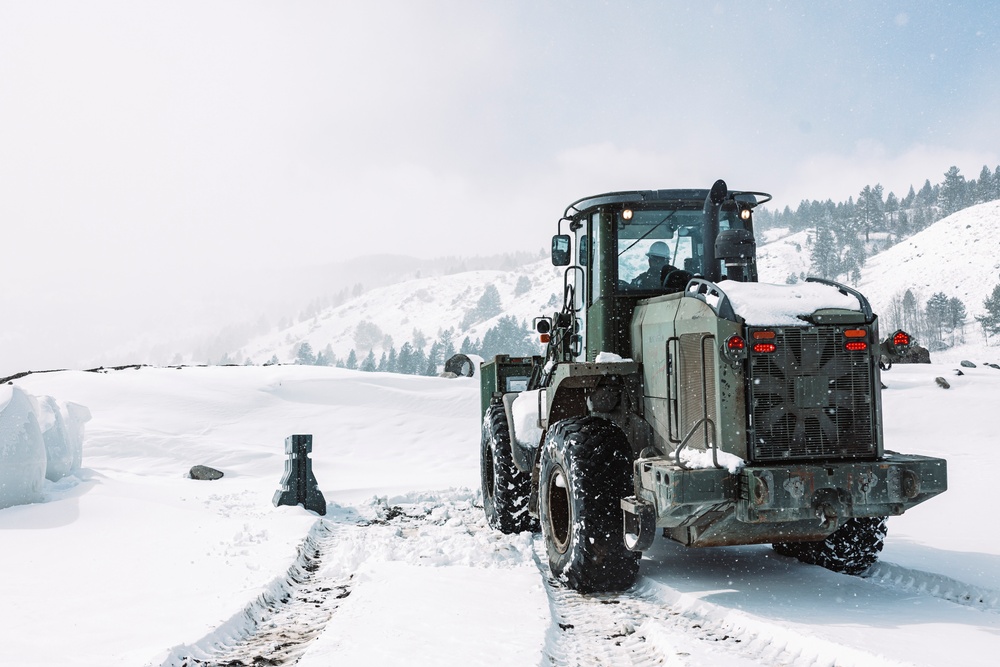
[479,404,536,534]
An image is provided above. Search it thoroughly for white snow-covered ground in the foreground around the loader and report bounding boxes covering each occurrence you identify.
[0,360,1000,667]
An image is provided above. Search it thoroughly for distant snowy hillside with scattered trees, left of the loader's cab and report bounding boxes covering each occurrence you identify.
[234,259,563,364]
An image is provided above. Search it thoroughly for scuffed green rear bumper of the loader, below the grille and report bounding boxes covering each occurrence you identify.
[622,452,948,546]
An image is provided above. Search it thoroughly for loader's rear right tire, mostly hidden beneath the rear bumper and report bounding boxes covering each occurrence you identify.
[771,516,888,575]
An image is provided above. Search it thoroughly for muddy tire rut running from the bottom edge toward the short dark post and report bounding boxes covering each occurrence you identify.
[162,519,351,667]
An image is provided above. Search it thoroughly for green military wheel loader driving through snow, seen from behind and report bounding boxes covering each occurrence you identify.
[481,180,947,592]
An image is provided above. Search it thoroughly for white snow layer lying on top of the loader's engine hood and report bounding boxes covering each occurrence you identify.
[719,280,861,326]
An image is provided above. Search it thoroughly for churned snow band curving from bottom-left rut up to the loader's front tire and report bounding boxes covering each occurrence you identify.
[161,491,531,667]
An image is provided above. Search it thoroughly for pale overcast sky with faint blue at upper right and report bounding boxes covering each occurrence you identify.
[0,0,1000,373]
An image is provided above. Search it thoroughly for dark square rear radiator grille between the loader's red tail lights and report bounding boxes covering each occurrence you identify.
[748,327,877,461]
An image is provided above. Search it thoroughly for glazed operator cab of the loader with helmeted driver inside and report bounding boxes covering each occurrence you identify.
[552,181,771,361]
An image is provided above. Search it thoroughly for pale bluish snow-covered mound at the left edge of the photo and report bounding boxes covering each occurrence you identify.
[0,386,90,509]
